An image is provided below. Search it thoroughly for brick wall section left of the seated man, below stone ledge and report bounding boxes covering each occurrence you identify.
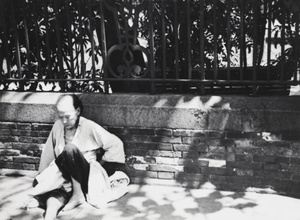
[0,122,52,170]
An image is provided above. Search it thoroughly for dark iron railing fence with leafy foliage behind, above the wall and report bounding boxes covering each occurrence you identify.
[0,0,300,95]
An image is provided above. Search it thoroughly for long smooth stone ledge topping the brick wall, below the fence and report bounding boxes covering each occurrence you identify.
[0,92,300,132]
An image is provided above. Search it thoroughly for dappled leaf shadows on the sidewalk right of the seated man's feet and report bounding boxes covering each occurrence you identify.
[59,185,256,220]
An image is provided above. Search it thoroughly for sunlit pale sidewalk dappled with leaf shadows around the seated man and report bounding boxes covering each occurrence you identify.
[0,176,300,220]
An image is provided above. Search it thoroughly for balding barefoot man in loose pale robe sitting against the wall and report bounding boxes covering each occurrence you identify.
[28,95,129,219]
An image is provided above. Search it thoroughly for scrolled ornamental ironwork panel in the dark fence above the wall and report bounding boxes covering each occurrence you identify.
[104,0,149,78]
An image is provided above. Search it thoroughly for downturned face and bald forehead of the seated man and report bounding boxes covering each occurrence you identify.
[56,96,80,129]
